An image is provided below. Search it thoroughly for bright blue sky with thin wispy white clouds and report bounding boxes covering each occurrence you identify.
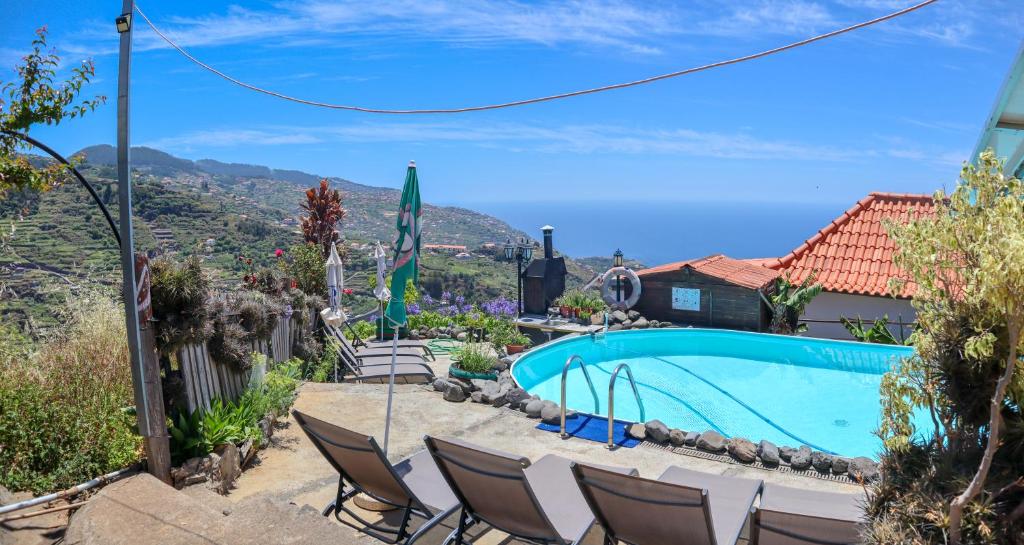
[0,0,1024,204]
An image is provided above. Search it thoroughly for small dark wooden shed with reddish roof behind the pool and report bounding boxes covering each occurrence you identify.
[634,254,779,331]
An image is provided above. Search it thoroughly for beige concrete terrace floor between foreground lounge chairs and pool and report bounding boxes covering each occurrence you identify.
[227,357,861,544]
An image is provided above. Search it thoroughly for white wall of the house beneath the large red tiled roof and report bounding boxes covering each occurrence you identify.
[801,292,916,339]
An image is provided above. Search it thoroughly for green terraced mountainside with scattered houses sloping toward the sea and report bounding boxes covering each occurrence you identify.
[0,145,593,328]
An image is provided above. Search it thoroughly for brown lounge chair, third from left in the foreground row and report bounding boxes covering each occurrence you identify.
[572,463,762,545]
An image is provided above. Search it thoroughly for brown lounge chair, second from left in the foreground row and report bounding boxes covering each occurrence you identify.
[424,436,636,545]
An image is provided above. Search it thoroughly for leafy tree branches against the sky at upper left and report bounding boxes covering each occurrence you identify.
[0,27,106,197]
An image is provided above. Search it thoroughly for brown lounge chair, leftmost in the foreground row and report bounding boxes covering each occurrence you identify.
[292,411,459,545]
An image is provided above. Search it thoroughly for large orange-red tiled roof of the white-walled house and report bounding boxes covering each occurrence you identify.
[764,193,935,298]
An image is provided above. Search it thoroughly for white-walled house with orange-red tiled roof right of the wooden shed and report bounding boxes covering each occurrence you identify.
[761,193,935,339]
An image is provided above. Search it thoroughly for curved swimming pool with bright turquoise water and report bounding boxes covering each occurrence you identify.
[512,329,925,458]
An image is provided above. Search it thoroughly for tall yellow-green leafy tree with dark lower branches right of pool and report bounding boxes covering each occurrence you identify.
[868,151,1024,544]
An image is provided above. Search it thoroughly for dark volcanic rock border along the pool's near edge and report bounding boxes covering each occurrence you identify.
[432,357,879,484]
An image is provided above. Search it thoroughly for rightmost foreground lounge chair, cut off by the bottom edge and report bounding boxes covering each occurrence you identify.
[751,485,864,545]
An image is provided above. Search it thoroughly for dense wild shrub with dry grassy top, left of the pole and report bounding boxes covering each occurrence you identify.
[0,294,141,494]
